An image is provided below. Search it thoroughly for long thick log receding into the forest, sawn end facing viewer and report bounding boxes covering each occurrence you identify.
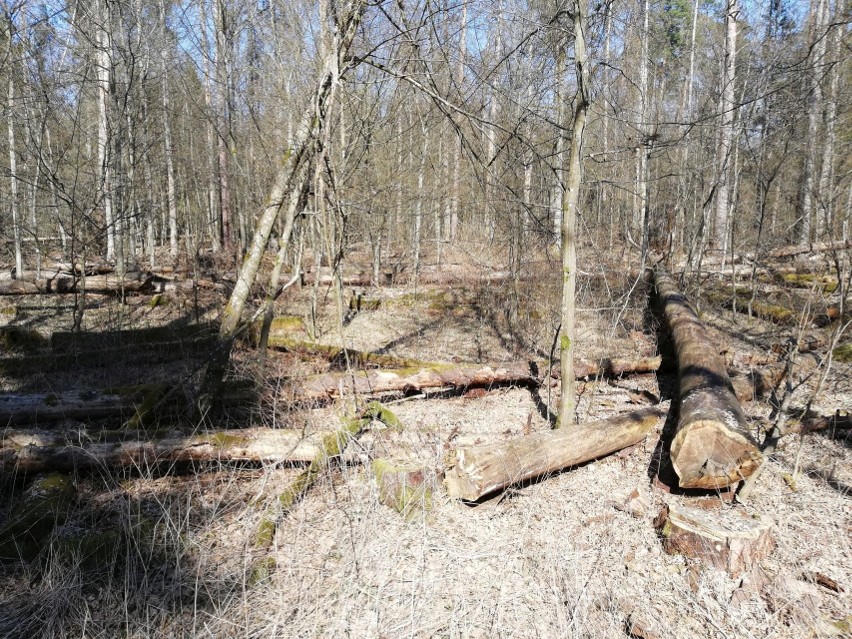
[655,268,763,490]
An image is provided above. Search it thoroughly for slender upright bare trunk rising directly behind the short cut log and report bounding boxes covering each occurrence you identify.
[559,0,591,428]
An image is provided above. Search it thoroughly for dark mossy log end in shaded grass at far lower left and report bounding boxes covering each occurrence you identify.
[0,473,76,560]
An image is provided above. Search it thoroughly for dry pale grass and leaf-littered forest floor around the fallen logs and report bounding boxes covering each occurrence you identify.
[0,242,852,639]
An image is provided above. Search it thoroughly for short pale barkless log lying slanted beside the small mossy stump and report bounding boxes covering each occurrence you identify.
[444,408,665,501]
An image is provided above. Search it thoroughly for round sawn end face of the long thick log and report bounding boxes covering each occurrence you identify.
[671,420,763,490]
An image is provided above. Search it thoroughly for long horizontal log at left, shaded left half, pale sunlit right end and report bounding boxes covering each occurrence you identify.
[0,428,345,473]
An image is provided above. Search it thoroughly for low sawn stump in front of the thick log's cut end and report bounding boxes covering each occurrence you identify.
[654,504,775,578]
